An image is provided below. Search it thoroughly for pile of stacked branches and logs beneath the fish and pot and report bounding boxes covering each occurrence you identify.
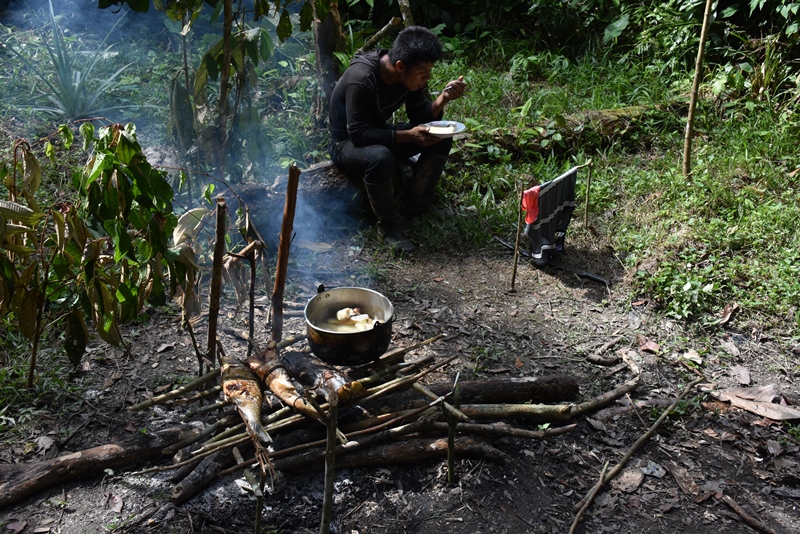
[0,336,638,510]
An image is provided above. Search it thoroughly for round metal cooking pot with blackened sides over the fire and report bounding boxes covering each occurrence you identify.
[304,287,394,365]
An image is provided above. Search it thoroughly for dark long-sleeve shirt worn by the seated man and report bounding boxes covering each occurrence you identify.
[328,50,440,148]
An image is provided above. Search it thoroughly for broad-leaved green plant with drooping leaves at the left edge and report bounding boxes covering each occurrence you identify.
[0,122,196,387]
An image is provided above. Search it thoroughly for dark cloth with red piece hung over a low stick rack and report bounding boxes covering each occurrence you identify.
[522,167,578,267]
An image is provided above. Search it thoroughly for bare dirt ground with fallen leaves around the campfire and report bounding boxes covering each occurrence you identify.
[0,173,800,534]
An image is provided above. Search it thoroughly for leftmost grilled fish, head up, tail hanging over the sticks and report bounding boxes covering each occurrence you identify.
[221,357,272,443]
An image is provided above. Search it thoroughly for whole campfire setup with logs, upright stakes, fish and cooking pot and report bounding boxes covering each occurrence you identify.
[0,168,680,531]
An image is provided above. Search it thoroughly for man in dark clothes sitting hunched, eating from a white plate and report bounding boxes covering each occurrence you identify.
[328,26,466,253]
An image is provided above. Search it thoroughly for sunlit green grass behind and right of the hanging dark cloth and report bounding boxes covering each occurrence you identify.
[424,32,800,334]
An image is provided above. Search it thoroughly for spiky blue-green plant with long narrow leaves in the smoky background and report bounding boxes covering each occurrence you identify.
[10,2,130,121]
